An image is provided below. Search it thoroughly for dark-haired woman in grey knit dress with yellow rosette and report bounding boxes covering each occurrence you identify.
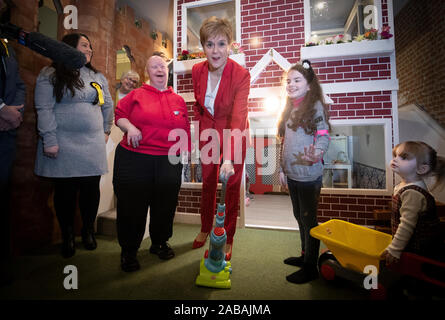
[35,33,113,257]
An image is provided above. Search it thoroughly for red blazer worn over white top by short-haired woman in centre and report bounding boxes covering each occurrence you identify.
[192,58,250,160]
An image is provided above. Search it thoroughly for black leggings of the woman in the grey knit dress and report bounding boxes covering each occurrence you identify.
[52,176,100,236]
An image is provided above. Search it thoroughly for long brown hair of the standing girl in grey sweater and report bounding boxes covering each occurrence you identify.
[278,60,331,138]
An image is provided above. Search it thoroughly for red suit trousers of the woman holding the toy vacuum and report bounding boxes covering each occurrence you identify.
[201,161,244,244]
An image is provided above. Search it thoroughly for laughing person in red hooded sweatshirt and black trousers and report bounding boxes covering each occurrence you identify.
[113,56,190,272]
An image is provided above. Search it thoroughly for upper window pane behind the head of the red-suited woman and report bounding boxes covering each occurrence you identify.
[187,1,236,52]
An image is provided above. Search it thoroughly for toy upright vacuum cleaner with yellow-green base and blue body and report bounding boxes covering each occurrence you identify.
[196,171,232,289]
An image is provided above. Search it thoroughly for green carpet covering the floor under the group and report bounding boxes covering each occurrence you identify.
[0,224,367,300]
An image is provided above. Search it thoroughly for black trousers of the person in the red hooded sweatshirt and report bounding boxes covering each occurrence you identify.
[113,145,182,251]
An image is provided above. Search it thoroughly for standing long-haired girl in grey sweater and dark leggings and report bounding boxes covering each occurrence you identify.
[278,60,330,283]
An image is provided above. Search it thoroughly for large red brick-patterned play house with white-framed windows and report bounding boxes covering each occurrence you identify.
[173,0,398,226]
